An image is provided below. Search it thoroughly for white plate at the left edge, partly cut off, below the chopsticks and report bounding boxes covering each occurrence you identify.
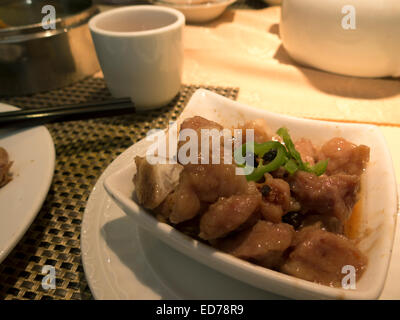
[0,103,55,262]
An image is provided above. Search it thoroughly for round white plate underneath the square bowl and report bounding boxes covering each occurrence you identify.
[81,135,400,300]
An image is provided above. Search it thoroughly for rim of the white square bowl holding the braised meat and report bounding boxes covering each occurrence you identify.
[104,89,397,299]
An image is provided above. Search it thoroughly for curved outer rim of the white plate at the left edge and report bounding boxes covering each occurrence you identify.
[0,103,55,263]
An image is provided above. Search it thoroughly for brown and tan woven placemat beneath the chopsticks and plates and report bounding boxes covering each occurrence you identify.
[0,78,238,299]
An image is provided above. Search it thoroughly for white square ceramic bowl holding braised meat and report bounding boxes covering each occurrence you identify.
[104,89,397,299]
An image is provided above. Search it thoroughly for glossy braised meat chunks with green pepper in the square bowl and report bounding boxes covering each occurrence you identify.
[134,116,369,286]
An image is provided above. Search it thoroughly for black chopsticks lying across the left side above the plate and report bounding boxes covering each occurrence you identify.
[0,98,136,129]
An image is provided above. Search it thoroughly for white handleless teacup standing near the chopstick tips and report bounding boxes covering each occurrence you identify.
[89,5,185,110]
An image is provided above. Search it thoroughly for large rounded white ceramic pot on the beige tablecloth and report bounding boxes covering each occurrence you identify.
[280,0,400,77]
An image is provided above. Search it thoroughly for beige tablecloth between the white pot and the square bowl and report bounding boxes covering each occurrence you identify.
[96,6,400,299]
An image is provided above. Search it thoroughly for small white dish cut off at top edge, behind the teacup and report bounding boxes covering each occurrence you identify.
[156,0,236,23]
